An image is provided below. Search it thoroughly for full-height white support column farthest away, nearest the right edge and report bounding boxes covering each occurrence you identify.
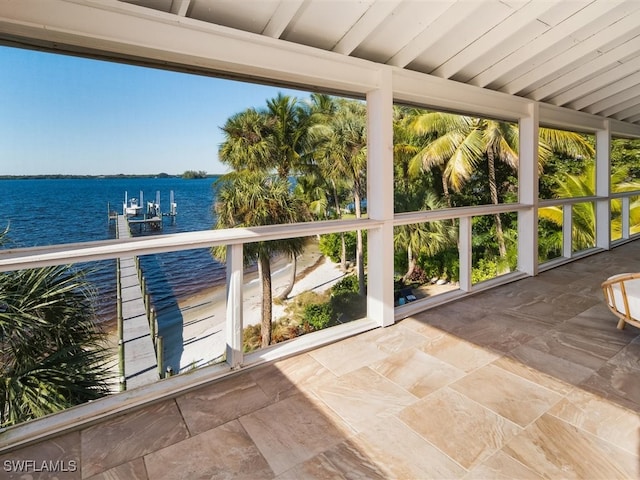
[596,125,611,250]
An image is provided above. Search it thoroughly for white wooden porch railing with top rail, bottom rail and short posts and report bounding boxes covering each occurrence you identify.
[0,192,639,451]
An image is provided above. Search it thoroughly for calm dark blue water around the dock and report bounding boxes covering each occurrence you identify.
[0,178,225,317]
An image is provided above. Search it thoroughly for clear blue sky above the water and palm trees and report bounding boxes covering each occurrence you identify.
[0,47,308,175]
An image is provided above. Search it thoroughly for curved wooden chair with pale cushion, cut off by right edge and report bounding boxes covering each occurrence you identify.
[602,273,640,330]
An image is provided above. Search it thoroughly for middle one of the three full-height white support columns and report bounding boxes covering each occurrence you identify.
[518,103,539,275]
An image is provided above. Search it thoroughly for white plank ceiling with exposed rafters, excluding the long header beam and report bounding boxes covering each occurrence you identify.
[125,0,640,124]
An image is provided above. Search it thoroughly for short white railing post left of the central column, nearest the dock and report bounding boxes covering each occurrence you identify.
[226,244,244,368]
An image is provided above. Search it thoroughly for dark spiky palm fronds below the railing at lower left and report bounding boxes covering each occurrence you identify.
[0,244,111,427]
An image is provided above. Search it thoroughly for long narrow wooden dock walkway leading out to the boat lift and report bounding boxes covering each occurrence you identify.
[117,215,160,390]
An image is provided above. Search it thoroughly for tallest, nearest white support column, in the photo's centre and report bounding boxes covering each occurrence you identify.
[367,68,394,327]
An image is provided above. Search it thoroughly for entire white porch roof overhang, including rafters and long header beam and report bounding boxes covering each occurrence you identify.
[0,0,640,137]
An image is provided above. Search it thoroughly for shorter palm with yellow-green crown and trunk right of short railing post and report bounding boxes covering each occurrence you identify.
[213,170,309,347]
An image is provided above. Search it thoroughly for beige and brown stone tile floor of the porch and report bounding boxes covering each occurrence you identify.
[0,242,640,480]
